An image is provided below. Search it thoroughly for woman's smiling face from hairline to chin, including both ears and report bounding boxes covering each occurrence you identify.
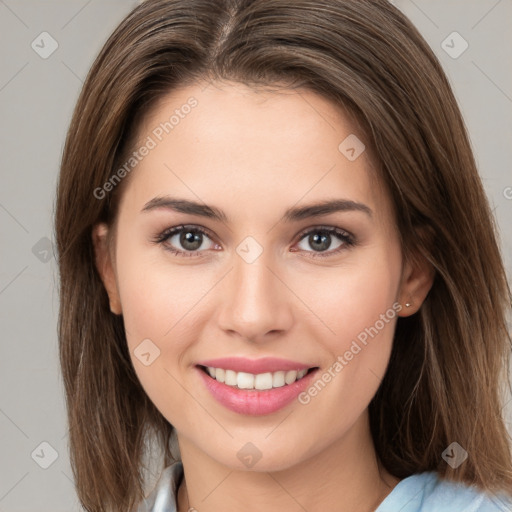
[94,79,427,471]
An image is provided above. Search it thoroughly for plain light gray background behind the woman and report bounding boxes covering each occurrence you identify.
[0,0,512,512]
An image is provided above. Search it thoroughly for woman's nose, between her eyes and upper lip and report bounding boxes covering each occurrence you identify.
[218,245,293,343]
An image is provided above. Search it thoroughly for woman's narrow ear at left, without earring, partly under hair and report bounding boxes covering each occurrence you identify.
[92,223,122,315]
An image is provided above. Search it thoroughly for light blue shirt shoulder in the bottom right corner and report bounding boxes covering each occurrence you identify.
[375,471,512,512]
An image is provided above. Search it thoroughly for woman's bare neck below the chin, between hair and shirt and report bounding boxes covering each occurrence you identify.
[177,412,399,512]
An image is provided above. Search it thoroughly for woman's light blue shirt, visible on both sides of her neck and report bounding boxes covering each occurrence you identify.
[136,461,512,512]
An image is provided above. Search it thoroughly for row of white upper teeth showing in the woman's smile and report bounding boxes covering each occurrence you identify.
[206,366,308,390]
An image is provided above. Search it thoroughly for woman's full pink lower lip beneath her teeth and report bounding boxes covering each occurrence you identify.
[196,367,318,416]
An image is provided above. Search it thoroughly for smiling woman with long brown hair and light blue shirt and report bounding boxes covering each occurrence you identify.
[56,0,512,512]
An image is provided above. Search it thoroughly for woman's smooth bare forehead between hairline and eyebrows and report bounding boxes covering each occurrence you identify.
[119,82,392,222]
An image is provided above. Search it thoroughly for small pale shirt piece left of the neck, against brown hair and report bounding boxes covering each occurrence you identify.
[132,461,183,512]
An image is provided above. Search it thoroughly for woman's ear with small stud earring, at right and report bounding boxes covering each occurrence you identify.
[398,248,435,316]
